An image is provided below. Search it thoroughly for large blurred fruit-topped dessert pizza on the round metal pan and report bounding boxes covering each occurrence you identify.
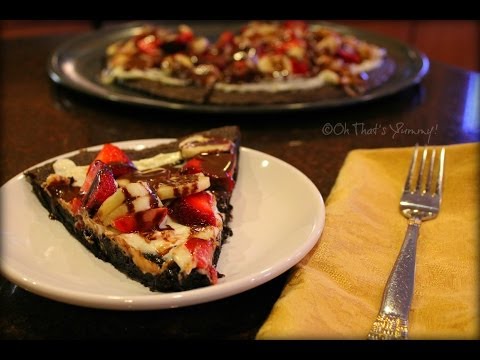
[101,21,395,105]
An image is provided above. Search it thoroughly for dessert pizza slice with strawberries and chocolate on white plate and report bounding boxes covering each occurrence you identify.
[25,126,240,292]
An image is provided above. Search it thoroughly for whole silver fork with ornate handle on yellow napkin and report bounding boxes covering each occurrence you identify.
[368,144,445,340]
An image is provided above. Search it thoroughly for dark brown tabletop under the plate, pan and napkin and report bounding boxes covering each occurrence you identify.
[0,36,480,339]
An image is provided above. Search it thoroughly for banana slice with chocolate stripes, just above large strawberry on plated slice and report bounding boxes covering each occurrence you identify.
[155,173,210,200]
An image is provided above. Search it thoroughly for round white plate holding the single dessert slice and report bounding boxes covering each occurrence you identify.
[0,139,325,310]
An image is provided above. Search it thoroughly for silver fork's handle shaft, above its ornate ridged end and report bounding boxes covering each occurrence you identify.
[380,216,422,321]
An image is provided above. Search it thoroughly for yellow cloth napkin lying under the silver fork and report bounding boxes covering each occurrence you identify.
[257,143,480,339]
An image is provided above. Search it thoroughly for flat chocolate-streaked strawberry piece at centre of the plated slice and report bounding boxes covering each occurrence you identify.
[112,207,168,233]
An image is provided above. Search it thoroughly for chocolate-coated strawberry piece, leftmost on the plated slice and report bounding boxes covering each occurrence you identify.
[82,165,117,214]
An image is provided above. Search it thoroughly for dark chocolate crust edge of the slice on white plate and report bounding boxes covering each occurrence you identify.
[25,126,240,292]
